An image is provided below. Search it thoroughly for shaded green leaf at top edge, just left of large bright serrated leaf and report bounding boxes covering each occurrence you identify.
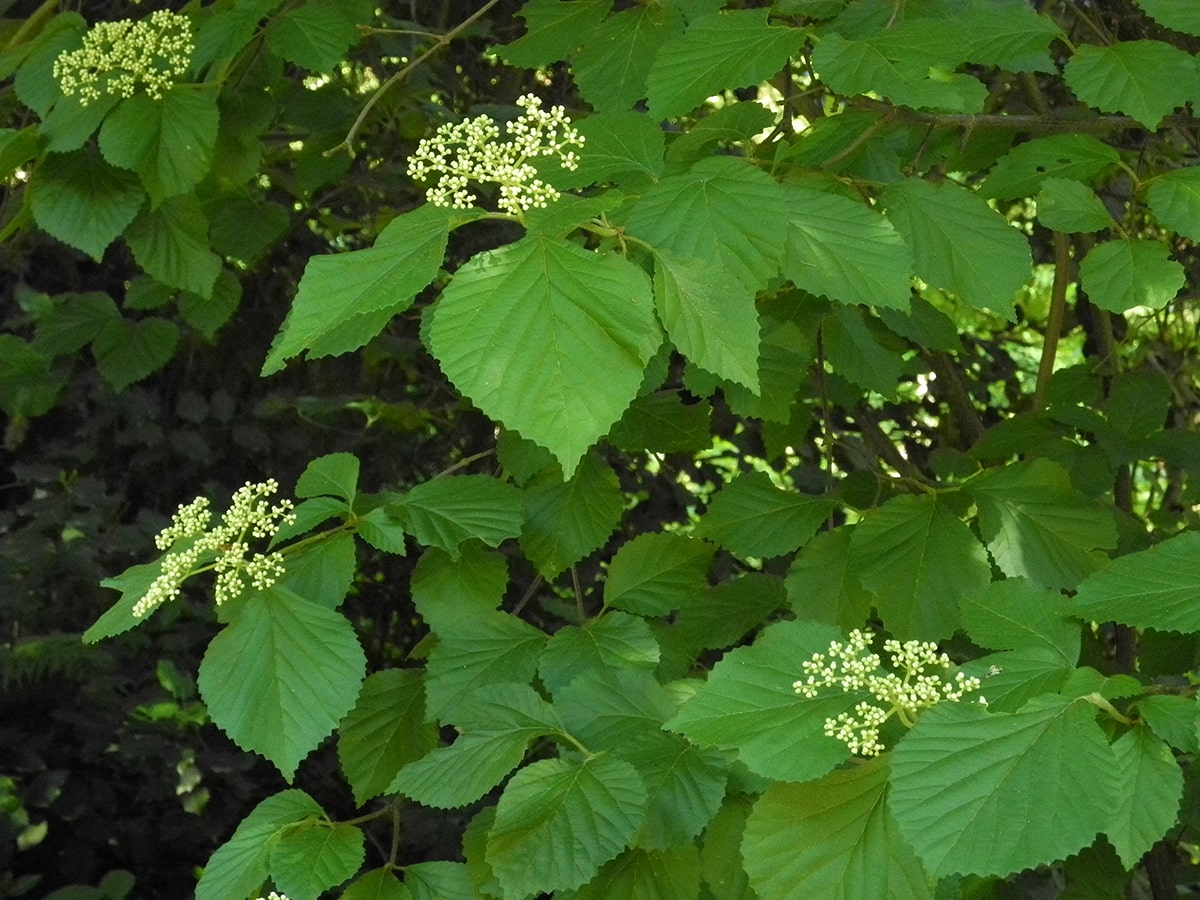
[571,4,683,112]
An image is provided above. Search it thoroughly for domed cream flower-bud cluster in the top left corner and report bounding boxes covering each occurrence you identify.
[53,10,194,106]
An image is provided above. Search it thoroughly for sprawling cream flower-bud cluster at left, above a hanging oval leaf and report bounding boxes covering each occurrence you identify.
[133,478,295,618]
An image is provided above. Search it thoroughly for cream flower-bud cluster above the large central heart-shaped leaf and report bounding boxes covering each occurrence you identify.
[408,94,583,216]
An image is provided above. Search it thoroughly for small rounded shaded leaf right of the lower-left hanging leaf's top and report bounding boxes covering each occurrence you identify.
[412,544,509,634]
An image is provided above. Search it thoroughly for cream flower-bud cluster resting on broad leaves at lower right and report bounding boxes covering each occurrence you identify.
[792,629,988,756]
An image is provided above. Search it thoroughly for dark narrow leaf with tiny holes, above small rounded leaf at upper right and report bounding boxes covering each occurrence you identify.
[980,134,1121,200]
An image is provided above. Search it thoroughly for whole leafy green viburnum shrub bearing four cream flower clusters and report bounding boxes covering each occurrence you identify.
[7,0,1200,900]
